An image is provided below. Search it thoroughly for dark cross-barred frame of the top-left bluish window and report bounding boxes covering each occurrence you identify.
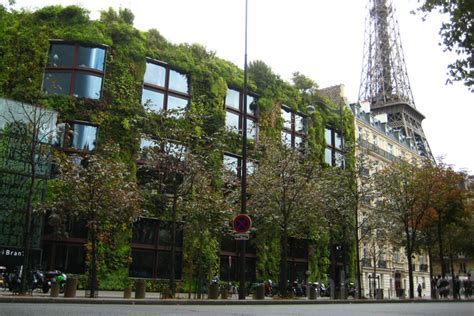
[42,39,108,100]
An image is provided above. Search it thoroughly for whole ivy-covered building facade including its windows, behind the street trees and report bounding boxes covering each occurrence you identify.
[0,6,354,292]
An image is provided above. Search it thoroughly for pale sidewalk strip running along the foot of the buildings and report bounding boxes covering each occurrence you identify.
[0,290,474,305]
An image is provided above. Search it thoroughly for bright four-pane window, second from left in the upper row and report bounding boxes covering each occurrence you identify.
[142,59,190,117]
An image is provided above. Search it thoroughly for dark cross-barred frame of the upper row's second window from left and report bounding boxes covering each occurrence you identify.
[142,57,191,112]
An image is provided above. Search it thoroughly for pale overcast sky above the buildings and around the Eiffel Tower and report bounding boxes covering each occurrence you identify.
[8,0,474,174]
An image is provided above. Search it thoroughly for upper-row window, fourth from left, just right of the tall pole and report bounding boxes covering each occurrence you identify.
[281,107,306,148]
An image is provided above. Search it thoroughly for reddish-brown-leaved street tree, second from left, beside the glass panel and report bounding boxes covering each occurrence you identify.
[47,145,141,297]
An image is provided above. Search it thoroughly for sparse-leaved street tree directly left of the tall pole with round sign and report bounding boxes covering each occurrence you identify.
[138,110,228,296]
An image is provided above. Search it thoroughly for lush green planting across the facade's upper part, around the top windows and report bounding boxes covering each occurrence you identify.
[0,6,354,286]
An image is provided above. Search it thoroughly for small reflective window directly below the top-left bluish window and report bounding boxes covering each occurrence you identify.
[57,121,98,152]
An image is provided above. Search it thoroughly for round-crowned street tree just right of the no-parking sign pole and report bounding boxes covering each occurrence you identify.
[248,139,323,296]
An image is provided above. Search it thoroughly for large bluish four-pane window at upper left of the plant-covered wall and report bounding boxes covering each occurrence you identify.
[43,41,106,99]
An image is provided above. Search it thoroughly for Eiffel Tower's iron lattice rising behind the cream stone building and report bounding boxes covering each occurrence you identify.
[359,0,433,160]
